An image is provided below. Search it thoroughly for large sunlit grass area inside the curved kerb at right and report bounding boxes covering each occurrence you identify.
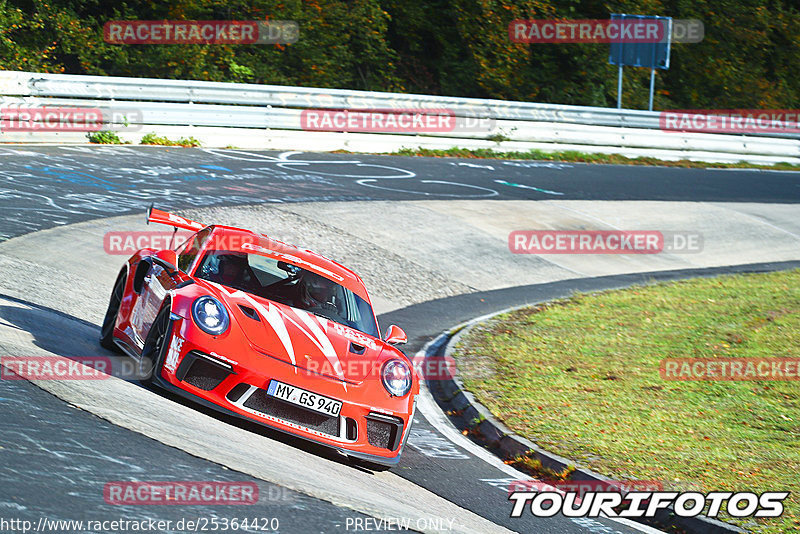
[455,270,800,533]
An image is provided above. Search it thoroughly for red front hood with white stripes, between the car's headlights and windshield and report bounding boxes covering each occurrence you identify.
[208,284,384,383]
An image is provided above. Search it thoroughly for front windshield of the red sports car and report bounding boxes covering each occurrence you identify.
[195,251,378,337]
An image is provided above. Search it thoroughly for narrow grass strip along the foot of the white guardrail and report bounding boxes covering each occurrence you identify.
[391,148,800,171]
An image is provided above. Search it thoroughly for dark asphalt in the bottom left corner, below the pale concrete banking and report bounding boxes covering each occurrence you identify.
[0,380,388,533]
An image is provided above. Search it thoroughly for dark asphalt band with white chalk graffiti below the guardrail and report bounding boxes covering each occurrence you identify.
[0,146,800,240]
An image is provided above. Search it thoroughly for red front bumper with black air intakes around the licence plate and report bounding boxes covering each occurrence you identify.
[155,319,415,466]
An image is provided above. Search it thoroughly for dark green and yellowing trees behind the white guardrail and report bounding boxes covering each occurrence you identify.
[0,0,800,109]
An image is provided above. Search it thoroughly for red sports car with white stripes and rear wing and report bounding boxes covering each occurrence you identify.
[100,207,419,465]
